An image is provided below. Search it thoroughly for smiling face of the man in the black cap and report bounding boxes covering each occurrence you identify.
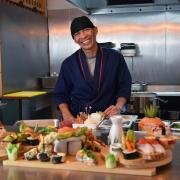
[74,27,97,50]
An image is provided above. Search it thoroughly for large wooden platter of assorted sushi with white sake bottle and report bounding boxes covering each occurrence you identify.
[0,116,177,176]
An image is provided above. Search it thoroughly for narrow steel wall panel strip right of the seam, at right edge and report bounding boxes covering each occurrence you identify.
[164,11,180,84]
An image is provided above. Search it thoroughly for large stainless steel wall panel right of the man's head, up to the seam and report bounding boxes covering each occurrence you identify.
[93,12,165,83]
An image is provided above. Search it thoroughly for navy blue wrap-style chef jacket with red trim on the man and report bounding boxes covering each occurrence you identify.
[55,47,132,116]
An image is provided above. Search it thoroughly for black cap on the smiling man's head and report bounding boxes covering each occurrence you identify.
[71,16,95,39]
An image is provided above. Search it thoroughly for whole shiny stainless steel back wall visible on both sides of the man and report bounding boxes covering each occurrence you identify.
[48,9,180,85]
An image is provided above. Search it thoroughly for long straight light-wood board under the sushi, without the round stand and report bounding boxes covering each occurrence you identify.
[3,156,156,176]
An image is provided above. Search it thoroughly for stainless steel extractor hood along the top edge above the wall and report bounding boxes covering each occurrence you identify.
[66,0,180,14]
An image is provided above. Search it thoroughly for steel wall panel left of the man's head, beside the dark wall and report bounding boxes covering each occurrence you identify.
[48,9,83,74]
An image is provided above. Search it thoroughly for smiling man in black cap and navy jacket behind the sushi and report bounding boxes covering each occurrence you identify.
[55,16,131,121]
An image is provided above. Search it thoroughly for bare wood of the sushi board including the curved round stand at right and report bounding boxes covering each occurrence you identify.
[3,139,173,176]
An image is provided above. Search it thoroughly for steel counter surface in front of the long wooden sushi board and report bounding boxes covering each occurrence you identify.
[0,141,180,180]
